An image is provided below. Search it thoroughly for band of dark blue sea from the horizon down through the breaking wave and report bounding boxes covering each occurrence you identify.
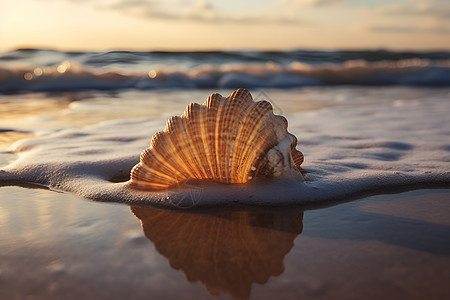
[0,49,450,92]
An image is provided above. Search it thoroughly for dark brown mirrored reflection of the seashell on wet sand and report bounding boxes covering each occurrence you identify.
[131,207,303,299]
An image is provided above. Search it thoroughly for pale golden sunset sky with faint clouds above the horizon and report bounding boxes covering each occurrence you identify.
[0,0,450,50]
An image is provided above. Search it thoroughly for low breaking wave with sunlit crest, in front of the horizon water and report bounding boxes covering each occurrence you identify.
[0,58,450,93]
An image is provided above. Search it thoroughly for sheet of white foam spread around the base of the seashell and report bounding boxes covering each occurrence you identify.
[0,99,450,207]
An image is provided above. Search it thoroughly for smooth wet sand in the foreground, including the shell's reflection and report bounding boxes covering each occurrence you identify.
[0,186,450,299]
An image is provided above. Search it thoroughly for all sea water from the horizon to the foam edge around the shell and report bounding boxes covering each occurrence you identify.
[0,49,450,207]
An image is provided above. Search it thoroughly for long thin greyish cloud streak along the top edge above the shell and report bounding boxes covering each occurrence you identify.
[101,0,302,24]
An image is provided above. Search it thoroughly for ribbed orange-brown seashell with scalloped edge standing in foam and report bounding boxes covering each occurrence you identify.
[131,89,303,190]
